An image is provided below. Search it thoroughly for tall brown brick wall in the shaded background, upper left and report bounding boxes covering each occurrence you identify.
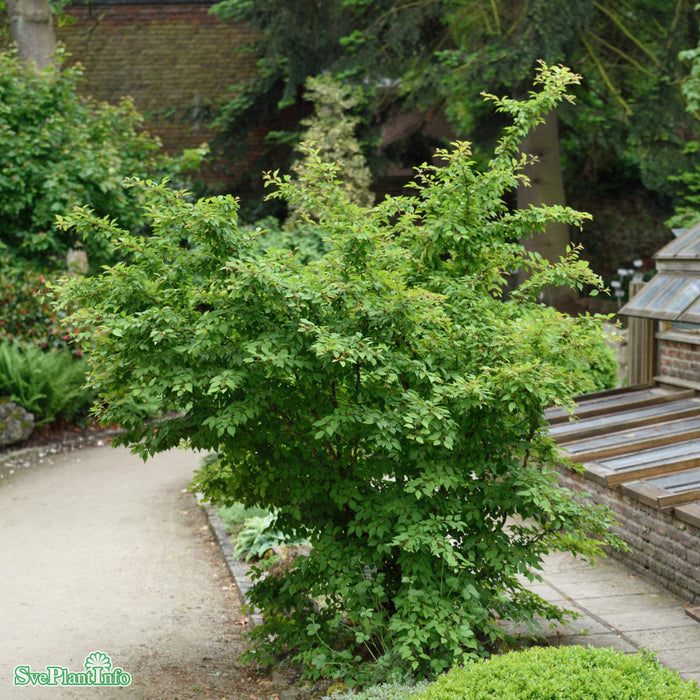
[56,0,256,165]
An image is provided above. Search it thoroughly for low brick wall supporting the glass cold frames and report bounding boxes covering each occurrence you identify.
[560,467,700,605]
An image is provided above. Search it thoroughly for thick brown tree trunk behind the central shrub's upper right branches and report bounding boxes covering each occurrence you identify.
[517,112,577,309]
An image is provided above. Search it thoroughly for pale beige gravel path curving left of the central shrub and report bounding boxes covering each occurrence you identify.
[0,446,276,700]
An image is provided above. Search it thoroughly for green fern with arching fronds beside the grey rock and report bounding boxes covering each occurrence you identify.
[0,342,94,425]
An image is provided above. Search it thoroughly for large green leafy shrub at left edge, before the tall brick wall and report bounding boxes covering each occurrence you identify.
[0,51,202,267]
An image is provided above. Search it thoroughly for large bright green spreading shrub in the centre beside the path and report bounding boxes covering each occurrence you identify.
[54,67,620,682]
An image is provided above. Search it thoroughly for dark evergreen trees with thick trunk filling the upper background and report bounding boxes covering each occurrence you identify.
[215,0,698,292]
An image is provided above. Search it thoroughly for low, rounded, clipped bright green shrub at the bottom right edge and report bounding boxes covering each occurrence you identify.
[418,646,700,700]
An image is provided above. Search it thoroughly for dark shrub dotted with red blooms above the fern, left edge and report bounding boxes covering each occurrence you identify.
[0,259,82,357]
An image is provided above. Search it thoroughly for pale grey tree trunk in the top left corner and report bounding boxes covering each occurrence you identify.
[6,0,56,69]
